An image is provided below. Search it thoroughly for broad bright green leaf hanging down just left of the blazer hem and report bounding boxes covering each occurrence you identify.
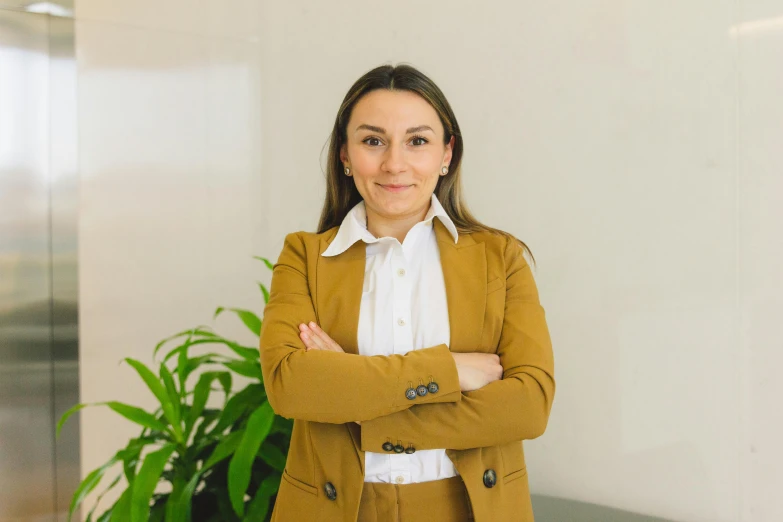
[228,402,275,517]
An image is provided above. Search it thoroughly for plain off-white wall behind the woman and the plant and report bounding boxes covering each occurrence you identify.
[76,0,783,522]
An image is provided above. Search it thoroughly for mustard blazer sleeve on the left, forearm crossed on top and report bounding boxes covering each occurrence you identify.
[259,233,462,424]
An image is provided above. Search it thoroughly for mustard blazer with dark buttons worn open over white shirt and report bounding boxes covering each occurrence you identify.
[260,219,555,522]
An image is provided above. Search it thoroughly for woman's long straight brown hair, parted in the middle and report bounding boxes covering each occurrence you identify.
[318,64,535,263]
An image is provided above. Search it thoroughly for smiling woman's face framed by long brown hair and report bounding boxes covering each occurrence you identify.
[340,89,454,220]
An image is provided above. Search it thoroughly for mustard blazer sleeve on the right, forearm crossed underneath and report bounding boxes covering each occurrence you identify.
[361,237,555,453]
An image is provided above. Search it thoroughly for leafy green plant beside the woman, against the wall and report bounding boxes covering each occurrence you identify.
[57,257,293,522]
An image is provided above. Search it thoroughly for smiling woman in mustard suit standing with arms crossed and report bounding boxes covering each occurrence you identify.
[260,65,555,522]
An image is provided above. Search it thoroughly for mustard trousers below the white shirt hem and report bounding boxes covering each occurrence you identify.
[358,475,473,522]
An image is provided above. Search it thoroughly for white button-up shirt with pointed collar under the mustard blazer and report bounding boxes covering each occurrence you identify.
[321,194,459,484]
